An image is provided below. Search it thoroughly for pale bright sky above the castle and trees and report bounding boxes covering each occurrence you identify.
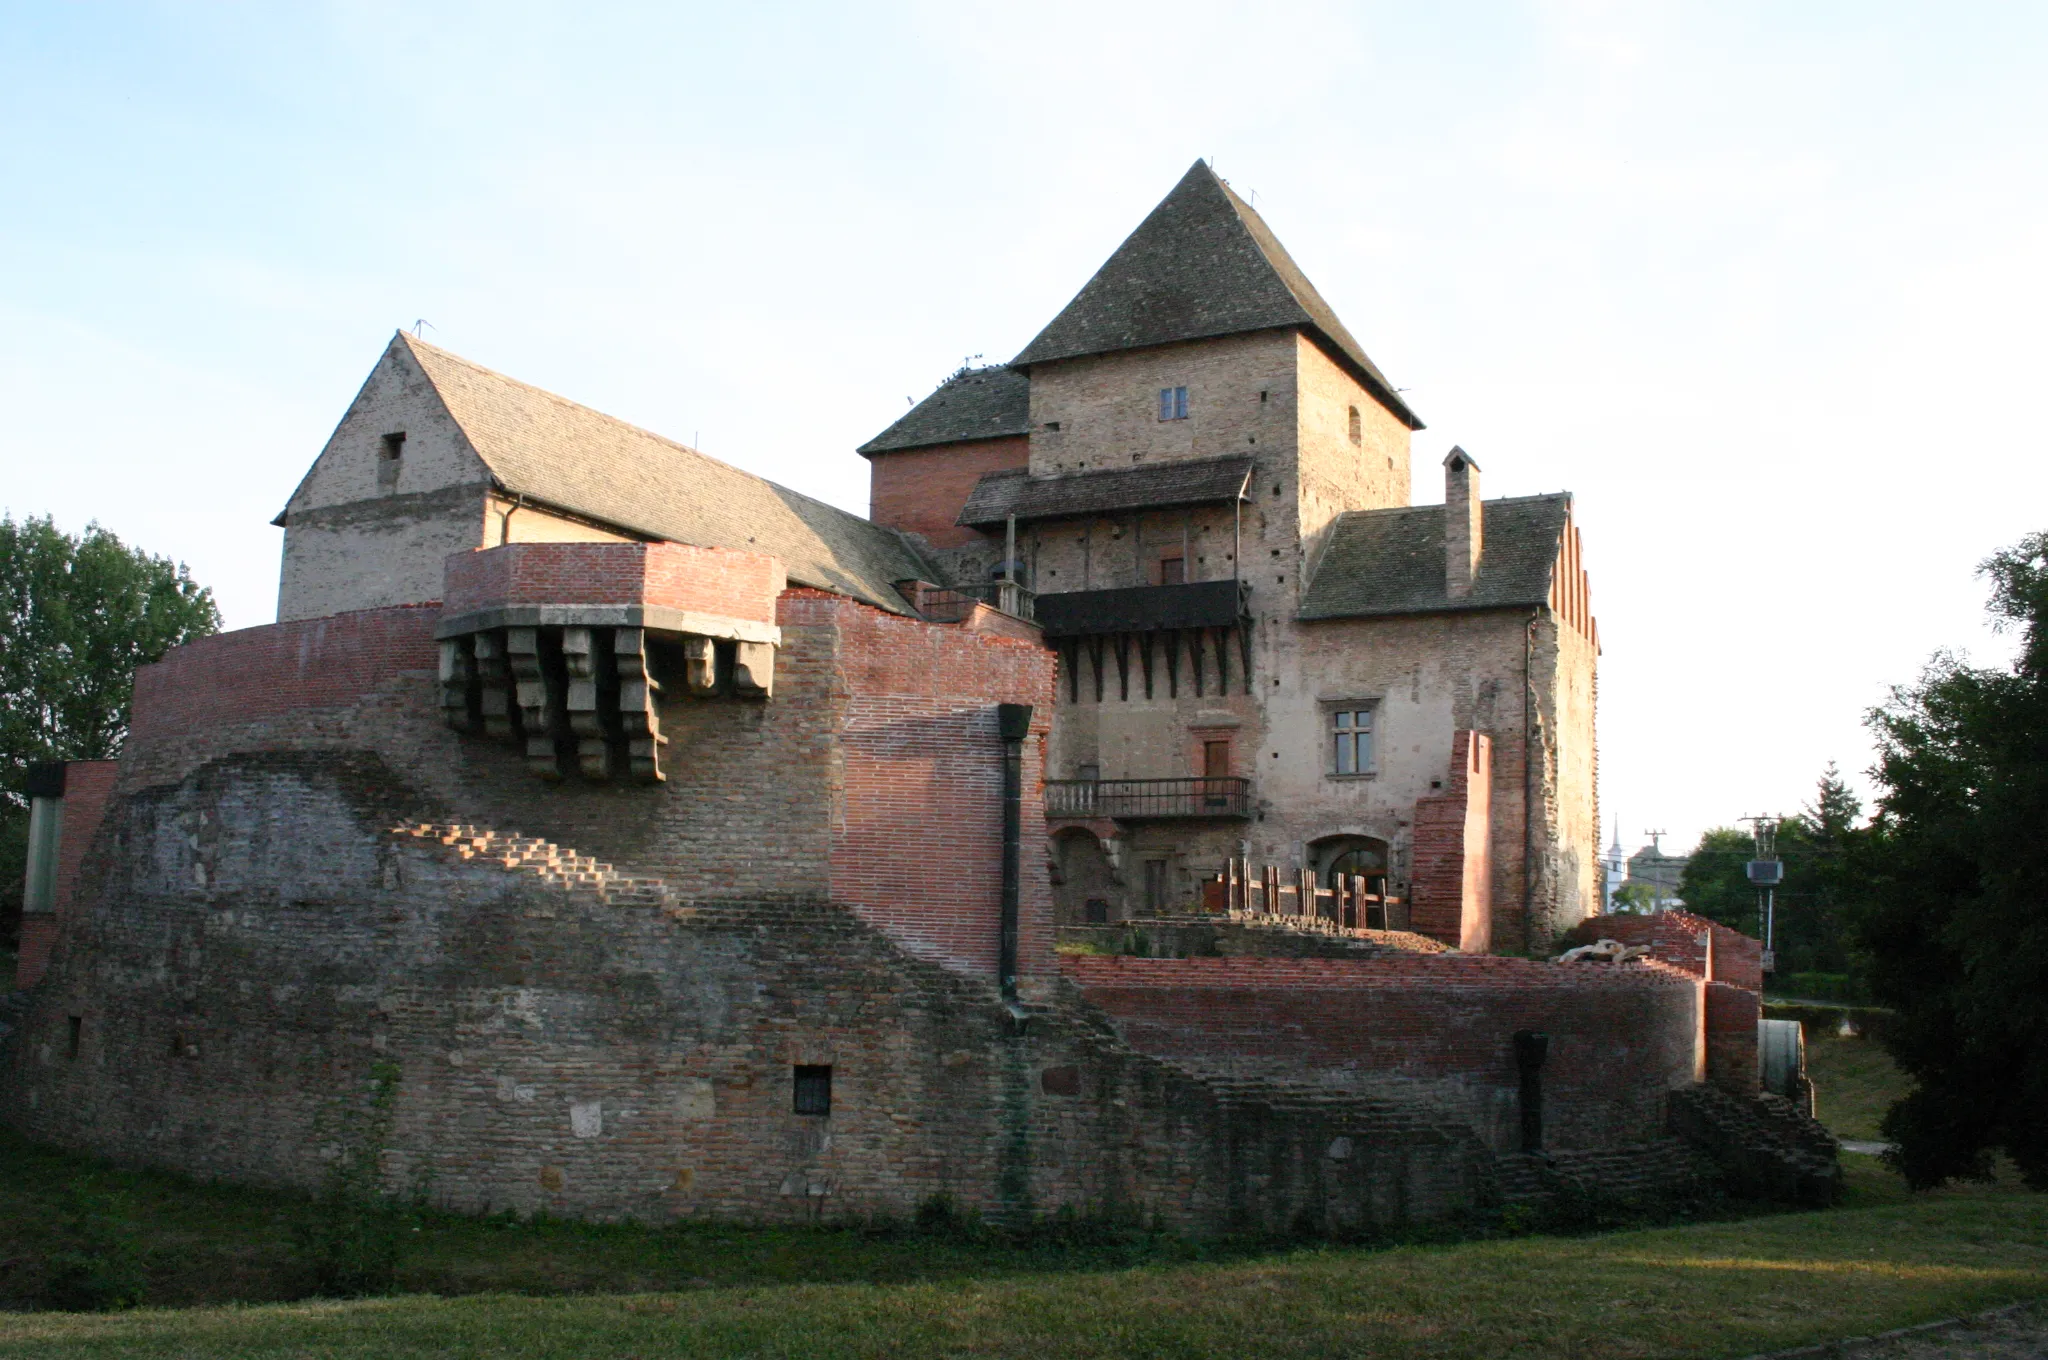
[0,0,2048,848]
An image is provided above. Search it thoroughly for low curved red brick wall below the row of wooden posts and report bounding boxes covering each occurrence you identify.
[1061,954,1703,1147]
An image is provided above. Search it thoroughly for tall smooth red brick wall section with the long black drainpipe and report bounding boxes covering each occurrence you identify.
[798,590,1055,979]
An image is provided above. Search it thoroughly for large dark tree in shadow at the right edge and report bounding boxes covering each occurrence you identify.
[1853,535,2048,1190]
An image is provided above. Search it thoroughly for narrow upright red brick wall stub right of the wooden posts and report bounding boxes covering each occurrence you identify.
[1409,731,1493,954]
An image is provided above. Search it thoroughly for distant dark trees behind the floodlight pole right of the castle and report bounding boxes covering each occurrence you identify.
[1677,764,1868,975]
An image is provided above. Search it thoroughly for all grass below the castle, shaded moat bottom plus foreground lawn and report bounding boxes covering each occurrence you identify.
[0,1139,2048,1360]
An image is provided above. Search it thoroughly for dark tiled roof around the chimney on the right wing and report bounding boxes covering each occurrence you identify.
[1300,492,1571,619]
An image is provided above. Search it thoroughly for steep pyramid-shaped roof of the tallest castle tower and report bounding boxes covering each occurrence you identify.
[1010,160,1421,430]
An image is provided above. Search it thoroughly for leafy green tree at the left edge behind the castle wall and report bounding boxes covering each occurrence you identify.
[0,516,221,934]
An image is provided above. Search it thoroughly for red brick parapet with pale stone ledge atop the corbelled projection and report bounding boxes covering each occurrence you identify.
[440,543,788,643]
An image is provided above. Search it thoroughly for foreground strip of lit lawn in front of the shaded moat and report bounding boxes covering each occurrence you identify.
[0,1167,2048,1360]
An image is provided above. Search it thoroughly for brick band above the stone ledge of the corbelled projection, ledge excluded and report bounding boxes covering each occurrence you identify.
[442,543,786,623]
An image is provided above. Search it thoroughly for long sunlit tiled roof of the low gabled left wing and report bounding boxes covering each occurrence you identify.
[395,332,932,614]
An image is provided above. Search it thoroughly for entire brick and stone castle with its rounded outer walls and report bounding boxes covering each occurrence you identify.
[0,164,1827,1233]
